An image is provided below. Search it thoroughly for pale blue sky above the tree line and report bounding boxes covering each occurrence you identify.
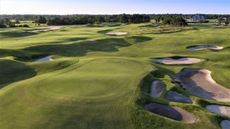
[0,0,230,14]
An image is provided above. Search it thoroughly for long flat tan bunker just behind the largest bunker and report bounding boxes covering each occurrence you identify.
[153,57,201,65]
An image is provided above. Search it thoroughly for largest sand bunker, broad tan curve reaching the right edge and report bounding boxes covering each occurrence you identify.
[174,68,230,102]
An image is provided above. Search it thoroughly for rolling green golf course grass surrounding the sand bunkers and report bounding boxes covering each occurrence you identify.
[0,25,230,129]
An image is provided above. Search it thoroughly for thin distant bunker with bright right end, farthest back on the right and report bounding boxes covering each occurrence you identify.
[187,45,224,51]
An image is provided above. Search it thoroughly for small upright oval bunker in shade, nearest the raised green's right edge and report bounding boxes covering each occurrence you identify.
[150,81,166,97]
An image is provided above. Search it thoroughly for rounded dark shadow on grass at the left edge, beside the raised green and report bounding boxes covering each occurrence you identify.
[0,60,36,89]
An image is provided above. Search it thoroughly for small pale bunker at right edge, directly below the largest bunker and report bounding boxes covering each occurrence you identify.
[206,105,230,117]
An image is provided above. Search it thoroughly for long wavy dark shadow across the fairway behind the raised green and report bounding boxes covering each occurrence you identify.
[23,38,131,57]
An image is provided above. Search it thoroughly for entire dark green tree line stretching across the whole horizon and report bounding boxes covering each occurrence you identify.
[0,14,230,28]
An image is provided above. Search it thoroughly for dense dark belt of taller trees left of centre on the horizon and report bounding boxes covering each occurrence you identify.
[41,14,151,25]
